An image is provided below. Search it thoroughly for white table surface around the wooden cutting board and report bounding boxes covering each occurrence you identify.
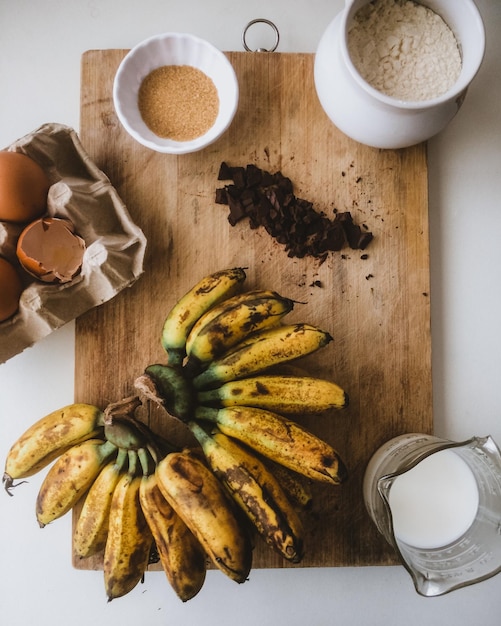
[0,0,501,626]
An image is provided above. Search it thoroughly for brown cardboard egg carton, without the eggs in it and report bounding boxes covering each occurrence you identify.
[0,124,146,363]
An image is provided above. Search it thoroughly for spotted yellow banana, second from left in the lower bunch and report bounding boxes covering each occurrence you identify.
[36,439,117,528]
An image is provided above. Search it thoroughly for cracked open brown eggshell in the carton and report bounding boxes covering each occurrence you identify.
[17,217,85,283]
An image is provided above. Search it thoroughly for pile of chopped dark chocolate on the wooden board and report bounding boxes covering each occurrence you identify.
[216,161,372,261]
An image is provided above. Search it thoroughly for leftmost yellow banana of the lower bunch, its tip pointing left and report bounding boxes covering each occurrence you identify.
[4,403,104,488]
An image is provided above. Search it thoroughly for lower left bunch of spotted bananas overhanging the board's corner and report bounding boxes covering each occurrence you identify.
[3,397,252,601]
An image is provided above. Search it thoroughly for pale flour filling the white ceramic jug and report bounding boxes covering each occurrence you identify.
[348,0,461,101]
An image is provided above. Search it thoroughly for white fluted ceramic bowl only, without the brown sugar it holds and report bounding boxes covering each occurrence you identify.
[113,32,239,154]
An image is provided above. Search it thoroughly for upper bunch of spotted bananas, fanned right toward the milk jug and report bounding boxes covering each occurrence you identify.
[135,268,348,563]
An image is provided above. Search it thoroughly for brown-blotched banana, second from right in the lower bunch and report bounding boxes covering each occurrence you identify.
[139,473,207,602]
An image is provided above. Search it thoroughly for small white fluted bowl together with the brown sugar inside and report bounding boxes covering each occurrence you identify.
[113,33,239,154]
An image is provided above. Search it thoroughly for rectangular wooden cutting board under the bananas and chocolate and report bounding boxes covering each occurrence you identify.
[75,50,432,569]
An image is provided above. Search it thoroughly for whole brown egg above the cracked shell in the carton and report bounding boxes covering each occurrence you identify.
[0,150,50,223]
